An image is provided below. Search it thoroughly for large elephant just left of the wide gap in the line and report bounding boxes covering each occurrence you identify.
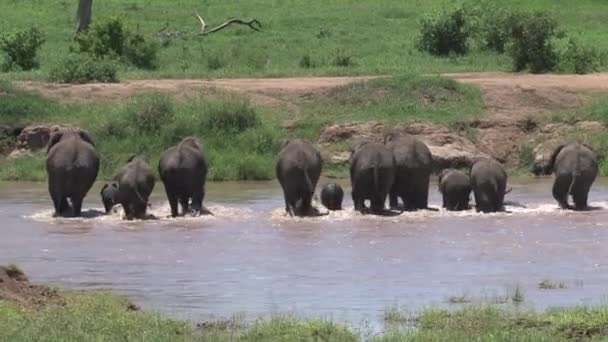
[158,137,211,217]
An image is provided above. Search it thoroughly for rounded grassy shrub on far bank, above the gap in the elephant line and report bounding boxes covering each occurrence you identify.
[203,99,258,132]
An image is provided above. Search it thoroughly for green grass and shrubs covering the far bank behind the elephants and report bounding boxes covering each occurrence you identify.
[0,76,481,181]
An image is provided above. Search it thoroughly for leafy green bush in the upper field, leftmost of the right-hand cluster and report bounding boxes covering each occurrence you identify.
[418,7,470,56]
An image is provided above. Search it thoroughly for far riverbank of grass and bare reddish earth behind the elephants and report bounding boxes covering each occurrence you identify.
[0,73,608,181]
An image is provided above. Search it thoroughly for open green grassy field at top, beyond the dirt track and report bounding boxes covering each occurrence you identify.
[0,0,608,79]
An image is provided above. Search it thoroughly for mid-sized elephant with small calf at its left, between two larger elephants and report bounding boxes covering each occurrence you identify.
[114,155,156,220]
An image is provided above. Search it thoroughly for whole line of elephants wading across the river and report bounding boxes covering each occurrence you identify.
[46,130,598,219]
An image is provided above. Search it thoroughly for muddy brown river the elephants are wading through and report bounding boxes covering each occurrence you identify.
[0,178,608,323]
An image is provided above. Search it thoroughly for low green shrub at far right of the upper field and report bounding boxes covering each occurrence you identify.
[559,38,601,74]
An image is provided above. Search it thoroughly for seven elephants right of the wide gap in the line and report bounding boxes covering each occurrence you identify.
[276,132,598,216]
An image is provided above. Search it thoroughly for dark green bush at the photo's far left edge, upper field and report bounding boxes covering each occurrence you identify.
[0,27,45,71]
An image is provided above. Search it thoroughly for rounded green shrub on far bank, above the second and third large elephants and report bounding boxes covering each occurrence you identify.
[126,94,175,133]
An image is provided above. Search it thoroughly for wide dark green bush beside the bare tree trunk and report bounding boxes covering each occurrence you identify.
[76,17,158,69]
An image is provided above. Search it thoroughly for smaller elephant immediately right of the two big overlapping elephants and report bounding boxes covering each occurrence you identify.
[438,169,472,211]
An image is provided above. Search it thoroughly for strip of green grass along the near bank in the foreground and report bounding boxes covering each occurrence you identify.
[0,293,608,342]
